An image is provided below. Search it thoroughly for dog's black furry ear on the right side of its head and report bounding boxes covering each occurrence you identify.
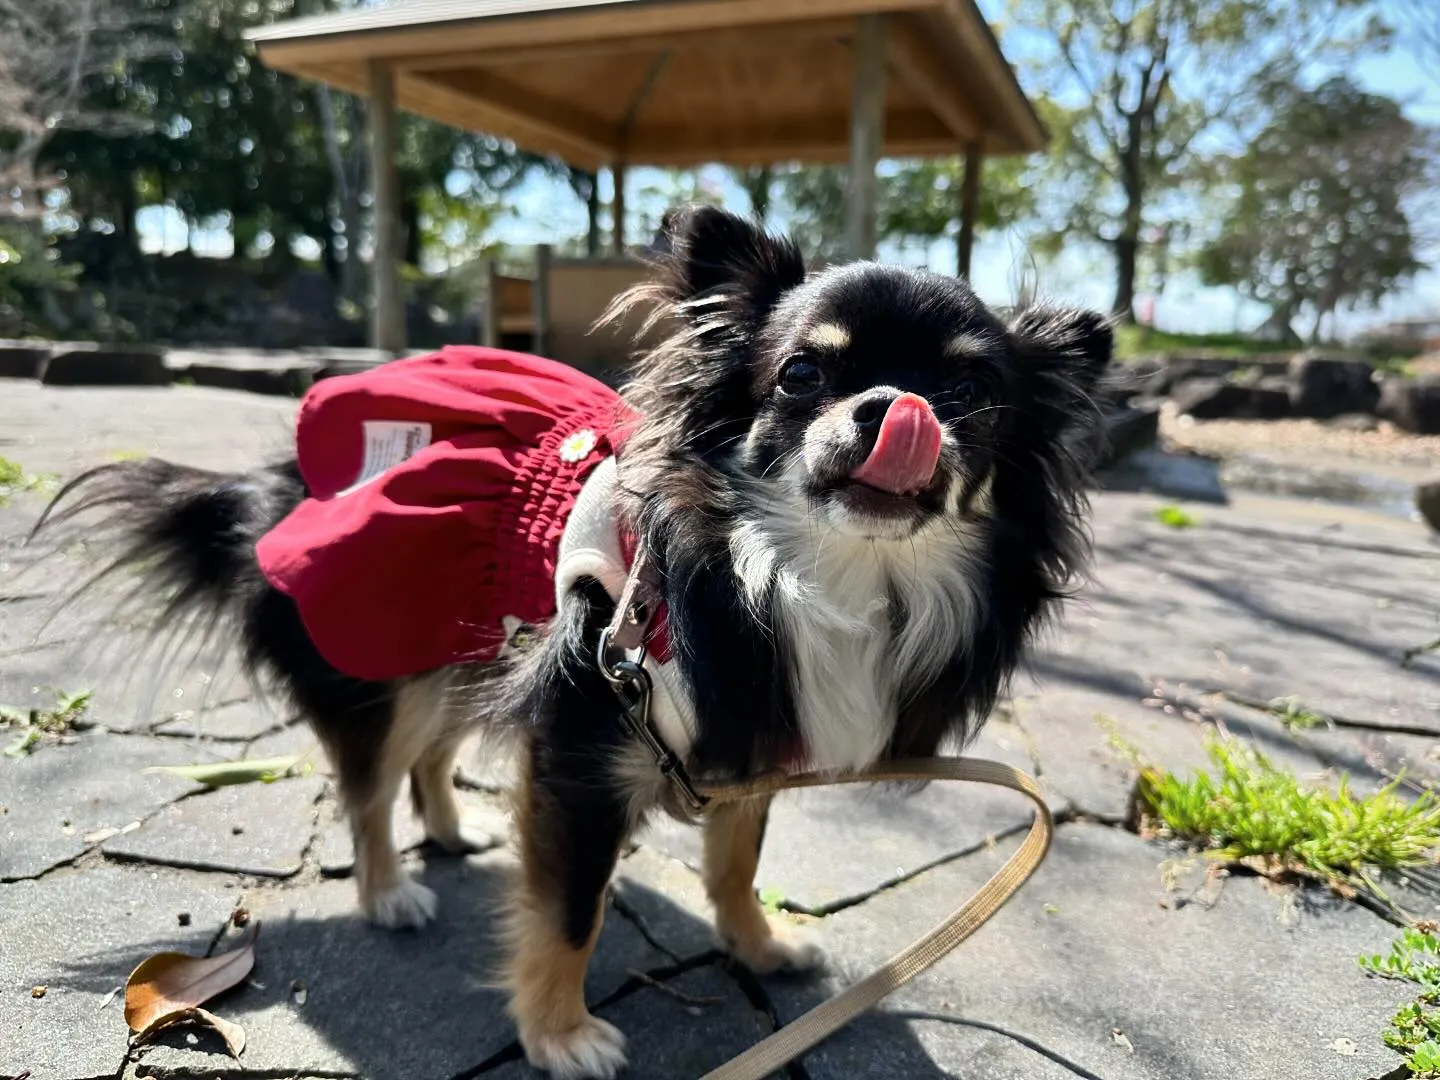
[1009,307,1115,438]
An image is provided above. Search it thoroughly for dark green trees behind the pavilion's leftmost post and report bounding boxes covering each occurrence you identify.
[36,0,536,294]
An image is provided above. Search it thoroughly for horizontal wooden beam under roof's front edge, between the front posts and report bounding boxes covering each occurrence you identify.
[395,19,854,71]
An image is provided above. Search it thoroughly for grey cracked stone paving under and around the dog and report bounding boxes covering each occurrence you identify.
[0,382,1440,1080]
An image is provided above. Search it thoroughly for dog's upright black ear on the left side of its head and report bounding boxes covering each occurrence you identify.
[661,206,805,318]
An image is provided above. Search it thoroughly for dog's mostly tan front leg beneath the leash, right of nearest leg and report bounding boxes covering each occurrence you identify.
[704,796,822,975]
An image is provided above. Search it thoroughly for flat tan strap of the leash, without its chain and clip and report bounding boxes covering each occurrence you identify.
[701,757,1054,1080]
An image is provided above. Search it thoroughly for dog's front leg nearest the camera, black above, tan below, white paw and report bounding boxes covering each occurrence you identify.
[507,744,629,1080]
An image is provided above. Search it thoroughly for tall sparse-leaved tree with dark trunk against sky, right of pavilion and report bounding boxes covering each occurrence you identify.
[1011,0,1378,321]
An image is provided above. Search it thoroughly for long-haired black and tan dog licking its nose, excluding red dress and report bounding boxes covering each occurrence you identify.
[36,209,1112,1077]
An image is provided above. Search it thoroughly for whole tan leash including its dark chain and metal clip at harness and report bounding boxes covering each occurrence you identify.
[596,546,1056,1080]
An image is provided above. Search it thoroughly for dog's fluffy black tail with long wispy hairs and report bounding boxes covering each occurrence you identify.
[30,458,305,688]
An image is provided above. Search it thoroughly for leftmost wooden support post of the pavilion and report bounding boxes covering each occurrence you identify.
[369,60,405,356]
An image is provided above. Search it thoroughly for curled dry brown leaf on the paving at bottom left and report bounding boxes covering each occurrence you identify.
[125,923,259,1054]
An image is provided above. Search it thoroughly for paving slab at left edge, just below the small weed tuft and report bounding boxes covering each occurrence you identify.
[0,730,200,878]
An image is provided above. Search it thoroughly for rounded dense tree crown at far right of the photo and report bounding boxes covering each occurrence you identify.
[1200,78,1433,340]
